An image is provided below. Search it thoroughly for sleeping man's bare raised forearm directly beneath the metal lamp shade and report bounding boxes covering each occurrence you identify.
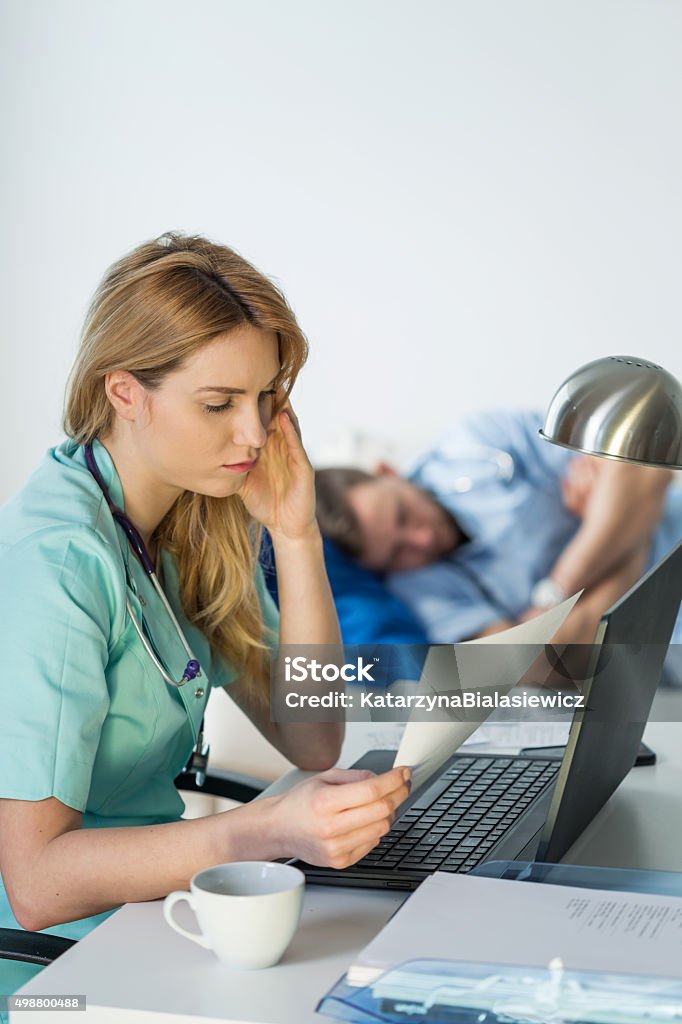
[550,457,673,594]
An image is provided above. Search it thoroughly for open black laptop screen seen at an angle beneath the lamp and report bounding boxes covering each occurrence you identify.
[536,543,682,863]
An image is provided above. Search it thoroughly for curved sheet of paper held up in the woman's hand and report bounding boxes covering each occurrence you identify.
[393,591,582,787]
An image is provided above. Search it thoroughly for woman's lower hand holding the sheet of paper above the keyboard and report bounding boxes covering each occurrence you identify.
[262,767,412,868]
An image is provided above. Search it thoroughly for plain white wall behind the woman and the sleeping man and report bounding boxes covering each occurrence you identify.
[0,0,682,499]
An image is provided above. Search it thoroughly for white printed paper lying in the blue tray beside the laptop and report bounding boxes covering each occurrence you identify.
[348,871,682,987]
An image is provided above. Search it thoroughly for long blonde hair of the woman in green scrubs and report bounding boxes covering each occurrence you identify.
[63,232,307,699]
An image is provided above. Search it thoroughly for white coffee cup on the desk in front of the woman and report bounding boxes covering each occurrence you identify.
[164,860,305,971]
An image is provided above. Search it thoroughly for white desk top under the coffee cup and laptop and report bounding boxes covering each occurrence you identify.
[11,715,682,1024]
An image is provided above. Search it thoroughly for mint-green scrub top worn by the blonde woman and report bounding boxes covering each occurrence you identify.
[0,440,279,993]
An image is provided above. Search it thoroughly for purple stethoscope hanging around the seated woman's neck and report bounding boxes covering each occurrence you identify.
[84,443,210,785]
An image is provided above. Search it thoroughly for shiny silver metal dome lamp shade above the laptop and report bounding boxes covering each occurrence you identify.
[540,355,682,469]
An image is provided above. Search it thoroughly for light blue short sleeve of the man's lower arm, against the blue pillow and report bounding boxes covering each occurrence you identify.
[388,561,501,643]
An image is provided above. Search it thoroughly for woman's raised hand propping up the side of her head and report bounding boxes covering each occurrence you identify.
[239,402,317,540]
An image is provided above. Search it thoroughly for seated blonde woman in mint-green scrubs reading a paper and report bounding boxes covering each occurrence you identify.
[0,234,409,991]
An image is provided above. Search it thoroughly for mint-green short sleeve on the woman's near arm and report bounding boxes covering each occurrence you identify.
[0,527,114,811]
